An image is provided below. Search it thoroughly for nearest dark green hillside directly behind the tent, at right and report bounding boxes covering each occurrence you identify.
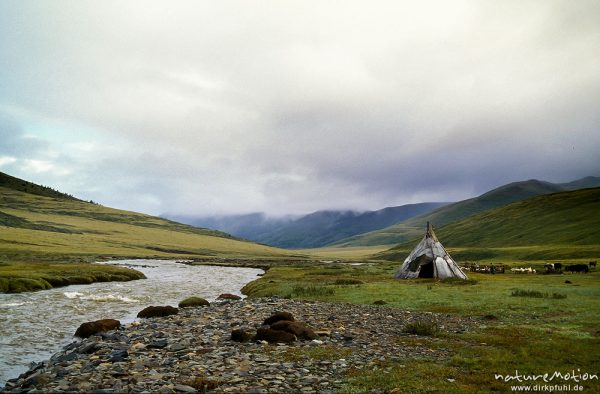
[377,188,600,260]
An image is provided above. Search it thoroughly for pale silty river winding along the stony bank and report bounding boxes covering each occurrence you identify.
[0,260,263,388]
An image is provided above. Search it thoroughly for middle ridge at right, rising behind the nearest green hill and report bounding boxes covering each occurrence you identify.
[334,177,600,246]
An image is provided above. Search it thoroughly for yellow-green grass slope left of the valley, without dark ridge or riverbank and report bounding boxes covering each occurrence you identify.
[0,187,291,258]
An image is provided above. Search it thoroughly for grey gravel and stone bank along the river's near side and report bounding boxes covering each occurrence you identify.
[2,298,477,393]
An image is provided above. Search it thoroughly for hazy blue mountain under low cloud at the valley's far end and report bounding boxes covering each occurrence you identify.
[168,202,448,249]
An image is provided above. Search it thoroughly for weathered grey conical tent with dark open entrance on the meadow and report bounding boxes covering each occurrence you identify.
[396,222,468,279]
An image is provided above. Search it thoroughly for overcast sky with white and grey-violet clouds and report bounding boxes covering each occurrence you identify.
[0,0,600,216]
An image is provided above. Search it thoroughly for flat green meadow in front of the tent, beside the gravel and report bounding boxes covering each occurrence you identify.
[243,262,600,393]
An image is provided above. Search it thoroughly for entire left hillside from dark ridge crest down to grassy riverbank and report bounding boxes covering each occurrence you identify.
[0,173,294,292]
